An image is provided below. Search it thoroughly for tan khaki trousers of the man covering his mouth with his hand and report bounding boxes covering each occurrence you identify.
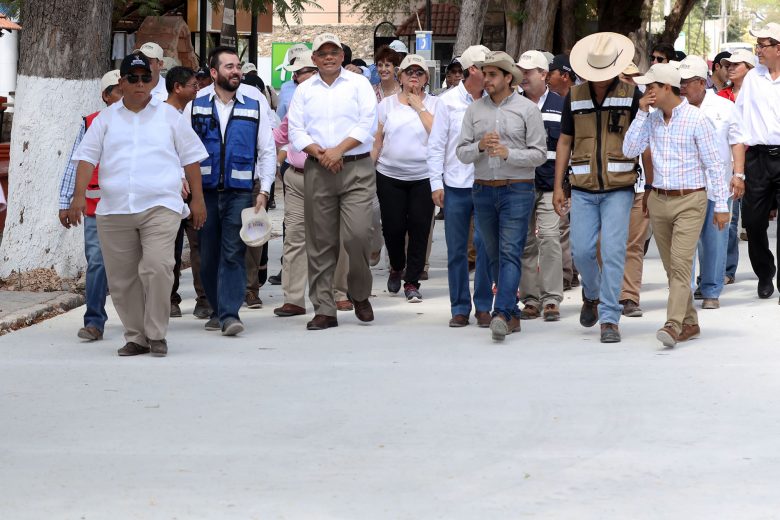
[647,191,707,334]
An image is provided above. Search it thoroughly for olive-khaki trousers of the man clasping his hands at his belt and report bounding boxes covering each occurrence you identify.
[304,157,376,316]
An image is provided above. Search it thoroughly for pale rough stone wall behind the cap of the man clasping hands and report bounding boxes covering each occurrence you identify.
[257,25,374,61]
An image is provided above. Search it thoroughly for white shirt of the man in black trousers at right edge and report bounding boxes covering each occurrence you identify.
[736,64,780,146]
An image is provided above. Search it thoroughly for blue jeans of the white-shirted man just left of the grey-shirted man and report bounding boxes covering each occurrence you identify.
[444,185,493,316]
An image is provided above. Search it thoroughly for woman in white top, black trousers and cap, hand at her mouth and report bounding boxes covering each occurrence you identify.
[372,54,438,303]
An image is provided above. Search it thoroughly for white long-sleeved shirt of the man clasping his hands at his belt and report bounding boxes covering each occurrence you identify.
[287,68,377,155]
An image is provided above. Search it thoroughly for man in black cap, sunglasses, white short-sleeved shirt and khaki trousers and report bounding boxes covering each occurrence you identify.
[69,54,207,356]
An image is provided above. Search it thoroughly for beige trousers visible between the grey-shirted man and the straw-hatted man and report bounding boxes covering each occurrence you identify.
[520,191,563,304]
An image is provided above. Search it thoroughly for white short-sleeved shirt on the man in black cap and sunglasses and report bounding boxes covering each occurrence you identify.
[71,96,208,216]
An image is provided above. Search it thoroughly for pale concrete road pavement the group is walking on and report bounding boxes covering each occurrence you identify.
[0,223,780,520]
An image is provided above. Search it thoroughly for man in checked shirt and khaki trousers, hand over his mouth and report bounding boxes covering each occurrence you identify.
[623,63,731,347]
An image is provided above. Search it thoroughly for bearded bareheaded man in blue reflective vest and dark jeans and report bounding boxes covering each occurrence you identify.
[189,47,276,336]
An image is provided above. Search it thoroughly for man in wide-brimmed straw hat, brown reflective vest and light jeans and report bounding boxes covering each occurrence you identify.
[553,33,640,343]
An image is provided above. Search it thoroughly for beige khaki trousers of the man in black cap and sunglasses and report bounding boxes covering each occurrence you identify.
[97,206,181,345]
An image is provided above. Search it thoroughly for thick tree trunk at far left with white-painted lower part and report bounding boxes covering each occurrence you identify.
[0,0,113,276]
